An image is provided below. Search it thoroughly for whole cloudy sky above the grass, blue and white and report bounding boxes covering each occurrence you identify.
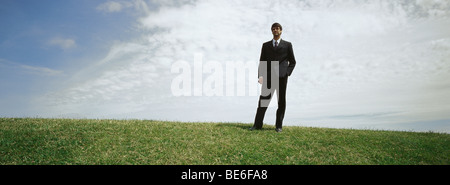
[0,0,450,133]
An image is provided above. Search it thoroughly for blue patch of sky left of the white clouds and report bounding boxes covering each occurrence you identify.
[0,0,141,115]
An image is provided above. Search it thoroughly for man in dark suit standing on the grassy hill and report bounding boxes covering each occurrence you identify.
[250,23,296,132]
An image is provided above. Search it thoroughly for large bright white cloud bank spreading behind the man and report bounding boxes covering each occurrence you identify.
[37,0,450,132]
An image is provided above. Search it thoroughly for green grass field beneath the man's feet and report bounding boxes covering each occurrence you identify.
[0,118,450,165]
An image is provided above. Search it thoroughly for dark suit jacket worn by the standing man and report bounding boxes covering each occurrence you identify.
[258,39,296,80]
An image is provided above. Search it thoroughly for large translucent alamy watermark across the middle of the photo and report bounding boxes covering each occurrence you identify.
[171,53,279,103]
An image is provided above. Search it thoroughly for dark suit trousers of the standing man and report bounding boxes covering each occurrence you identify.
[253,76,288,129]
